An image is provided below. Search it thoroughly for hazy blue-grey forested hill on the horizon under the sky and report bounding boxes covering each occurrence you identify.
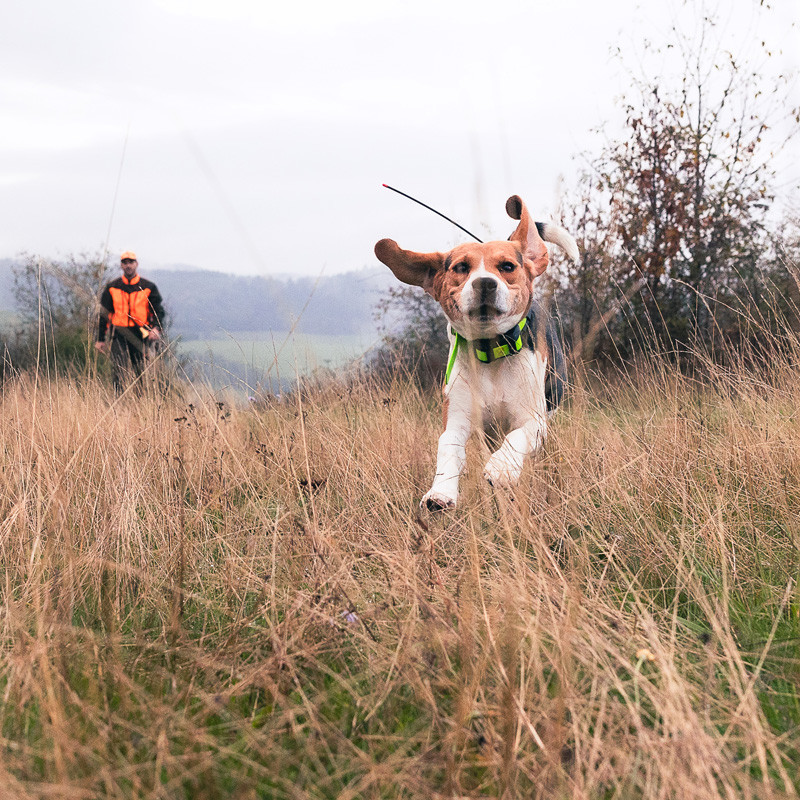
[0,258,394,339]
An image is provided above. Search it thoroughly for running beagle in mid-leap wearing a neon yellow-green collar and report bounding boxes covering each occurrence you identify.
[375,195,578,511]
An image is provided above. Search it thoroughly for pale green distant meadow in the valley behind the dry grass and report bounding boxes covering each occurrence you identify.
[177,331,376,393]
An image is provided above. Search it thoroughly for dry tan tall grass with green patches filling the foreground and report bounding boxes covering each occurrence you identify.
[0,344,800,798]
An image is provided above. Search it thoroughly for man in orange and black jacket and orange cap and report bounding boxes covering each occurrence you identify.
[95,250,164,392]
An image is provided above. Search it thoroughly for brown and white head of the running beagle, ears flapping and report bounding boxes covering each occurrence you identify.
[375,195,574,339]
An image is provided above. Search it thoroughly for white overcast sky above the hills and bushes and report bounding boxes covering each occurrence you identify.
[0,0,800,275]
